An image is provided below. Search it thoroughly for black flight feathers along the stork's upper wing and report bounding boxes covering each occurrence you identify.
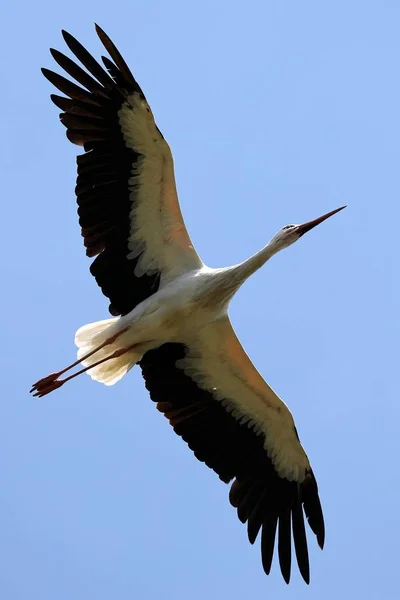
[42,28,160,315]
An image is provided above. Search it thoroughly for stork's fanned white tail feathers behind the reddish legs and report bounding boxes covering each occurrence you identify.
[75,318,142,385]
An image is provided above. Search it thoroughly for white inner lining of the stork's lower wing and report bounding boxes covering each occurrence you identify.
[177,317,310,483]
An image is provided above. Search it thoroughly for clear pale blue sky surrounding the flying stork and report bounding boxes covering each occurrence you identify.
[0,0,400,600]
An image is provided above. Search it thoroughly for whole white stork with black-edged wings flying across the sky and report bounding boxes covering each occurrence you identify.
[31,25,344,583]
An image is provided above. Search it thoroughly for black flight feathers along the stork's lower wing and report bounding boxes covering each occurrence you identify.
[140,344,324,583]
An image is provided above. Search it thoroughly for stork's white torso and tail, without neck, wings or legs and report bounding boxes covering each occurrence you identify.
[75,266,232,385]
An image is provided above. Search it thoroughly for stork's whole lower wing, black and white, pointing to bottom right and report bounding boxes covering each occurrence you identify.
[140,317,325,583]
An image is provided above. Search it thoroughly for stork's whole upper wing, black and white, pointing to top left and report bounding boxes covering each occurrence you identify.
[42,26,202,315]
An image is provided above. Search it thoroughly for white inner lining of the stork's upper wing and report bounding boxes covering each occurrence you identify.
[118,93,203,285]
